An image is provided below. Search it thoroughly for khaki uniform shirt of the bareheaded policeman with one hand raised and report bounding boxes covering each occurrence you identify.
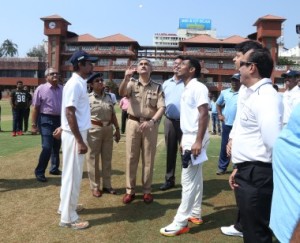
[127,79,165,118]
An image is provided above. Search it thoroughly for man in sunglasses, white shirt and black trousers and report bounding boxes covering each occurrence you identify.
[230,48,283,243]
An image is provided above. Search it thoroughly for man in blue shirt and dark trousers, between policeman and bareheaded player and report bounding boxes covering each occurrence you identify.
[160,56,184,191]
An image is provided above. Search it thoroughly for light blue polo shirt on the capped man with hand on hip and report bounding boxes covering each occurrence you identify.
[216,88,239,126]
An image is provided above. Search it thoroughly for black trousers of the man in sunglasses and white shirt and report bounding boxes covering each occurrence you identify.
[235,161,273,243]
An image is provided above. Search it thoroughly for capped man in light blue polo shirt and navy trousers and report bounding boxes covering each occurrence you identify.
[216,73,240,175]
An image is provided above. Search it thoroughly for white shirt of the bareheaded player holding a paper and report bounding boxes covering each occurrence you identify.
[180,78,209,150]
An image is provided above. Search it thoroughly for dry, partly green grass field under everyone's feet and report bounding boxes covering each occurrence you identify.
[0,100,242,242]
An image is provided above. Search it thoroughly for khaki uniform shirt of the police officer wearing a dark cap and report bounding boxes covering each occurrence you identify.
[89,92,115,122]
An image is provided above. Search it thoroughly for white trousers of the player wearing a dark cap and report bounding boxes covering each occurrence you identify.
[59,130,87,223]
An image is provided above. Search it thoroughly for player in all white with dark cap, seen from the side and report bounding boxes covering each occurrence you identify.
[59,51,97,229]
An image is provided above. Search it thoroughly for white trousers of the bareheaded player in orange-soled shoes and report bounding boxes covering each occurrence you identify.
[173,163,203,227]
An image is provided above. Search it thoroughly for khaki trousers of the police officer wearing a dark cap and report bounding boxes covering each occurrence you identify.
[86,125,113,189]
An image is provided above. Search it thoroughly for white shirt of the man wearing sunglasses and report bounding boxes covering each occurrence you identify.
[230,78,283,164]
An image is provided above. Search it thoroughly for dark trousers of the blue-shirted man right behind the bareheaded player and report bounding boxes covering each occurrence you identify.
[164,117,182,182]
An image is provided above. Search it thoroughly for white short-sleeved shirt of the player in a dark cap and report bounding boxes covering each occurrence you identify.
[61,73,91,131]
